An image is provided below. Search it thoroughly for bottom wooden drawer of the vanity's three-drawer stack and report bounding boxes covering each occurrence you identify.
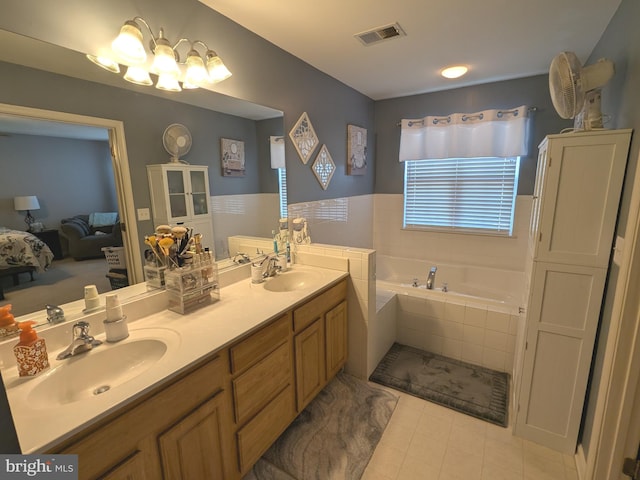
[237,385,294,475]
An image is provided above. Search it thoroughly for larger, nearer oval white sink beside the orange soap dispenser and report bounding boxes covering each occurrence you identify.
[27,329,179,408]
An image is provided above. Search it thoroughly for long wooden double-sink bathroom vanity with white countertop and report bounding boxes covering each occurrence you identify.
[7,266,348,479]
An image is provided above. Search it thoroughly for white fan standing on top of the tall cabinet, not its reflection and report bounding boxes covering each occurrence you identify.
[549,52,614,131]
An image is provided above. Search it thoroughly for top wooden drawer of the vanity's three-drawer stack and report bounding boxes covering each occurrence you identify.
[229,313,291,374]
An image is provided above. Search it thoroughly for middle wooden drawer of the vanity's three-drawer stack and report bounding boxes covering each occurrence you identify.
[233,342,293,425]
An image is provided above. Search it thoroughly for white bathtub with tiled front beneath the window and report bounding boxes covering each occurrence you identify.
[376,255,524,375]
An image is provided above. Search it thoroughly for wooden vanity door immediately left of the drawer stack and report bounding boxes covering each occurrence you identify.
[158,392,227,480]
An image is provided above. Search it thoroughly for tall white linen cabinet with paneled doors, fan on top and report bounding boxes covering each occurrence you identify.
[514,130,631,454]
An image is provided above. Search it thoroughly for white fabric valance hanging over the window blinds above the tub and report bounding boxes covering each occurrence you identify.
[399,106,529,162]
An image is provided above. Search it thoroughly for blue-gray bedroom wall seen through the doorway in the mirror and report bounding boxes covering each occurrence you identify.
[0,134,118,230]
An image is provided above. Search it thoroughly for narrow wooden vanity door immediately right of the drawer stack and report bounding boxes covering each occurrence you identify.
[295,318,326,412]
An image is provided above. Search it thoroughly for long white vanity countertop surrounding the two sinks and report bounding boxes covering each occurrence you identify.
[2,265,348,453]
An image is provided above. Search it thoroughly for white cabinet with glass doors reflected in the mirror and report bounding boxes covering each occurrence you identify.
[147,163,214,252]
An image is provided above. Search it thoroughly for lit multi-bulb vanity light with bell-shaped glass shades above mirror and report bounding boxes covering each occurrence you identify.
[87,17,231,92]
